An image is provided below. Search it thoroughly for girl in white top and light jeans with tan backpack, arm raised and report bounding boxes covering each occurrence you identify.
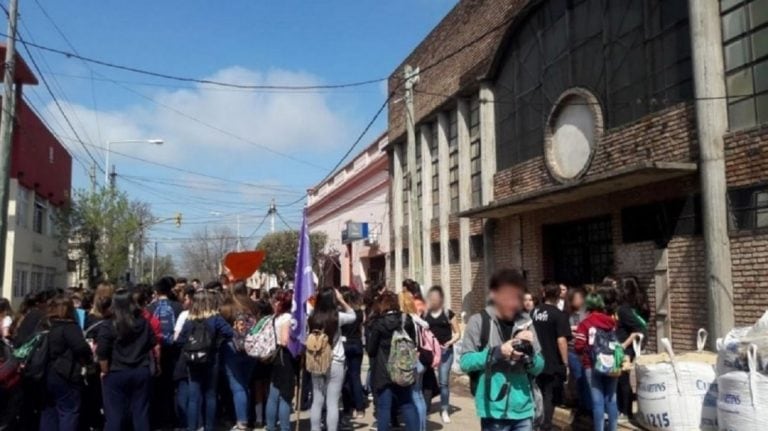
[305,288,357,431]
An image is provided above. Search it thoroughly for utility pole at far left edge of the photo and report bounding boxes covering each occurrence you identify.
[0,0,18,286]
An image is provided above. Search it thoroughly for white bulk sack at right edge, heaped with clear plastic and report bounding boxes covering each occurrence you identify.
[717,311,768,431]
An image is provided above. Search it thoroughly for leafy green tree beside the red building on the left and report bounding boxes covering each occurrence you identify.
[57,187,152,286]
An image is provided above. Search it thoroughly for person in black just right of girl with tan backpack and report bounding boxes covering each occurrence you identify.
[341,288,365,419]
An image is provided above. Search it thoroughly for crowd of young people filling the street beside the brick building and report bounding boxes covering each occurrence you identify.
[0,270,648,431]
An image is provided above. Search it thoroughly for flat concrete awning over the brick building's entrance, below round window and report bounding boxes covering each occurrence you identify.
[459,162,697,218]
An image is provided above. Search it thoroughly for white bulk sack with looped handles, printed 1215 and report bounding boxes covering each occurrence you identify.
[634,329,718,431]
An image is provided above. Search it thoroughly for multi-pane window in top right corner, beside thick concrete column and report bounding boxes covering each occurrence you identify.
[720,0,768,130]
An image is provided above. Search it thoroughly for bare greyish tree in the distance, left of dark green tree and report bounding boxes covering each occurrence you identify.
[181,226,237,280]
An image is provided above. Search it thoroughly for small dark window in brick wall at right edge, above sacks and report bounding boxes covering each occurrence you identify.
[728,184,768,231]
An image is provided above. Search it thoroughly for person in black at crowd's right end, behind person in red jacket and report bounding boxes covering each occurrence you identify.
[616,278,650,423]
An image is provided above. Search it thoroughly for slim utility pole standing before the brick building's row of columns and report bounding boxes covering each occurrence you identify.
[403,65,424,283]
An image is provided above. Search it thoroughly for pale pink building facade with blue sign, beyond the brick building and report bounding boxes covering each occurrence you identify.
[307,135,391,289]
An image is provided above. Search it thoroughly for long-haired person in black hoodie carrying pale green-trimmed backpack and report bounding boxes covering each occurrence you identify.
[368,291,419,431]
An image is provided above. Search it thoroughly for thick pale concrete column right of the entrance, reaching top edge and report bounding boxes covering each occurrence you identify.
[688,0,735,340]
